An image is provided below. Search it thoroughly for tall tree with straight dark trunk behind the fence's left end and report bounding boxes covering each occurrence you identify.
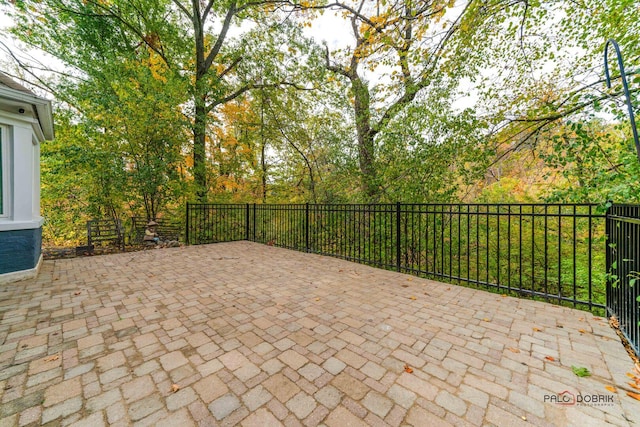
[8,0,320,200]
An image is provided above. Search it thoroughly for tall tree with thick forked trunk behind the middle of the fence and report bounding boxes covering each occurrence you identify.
[282,0,516,201]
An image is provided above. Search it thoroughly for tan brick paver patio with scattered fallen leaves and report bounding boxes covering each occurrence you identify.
[0,242,640,427]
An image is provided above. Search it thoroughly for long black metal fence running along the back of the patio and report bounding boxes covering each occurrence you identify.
[187,203,604,312]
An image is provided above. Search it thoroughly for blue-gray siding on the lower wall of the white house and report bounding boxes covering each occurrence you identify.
[0,228,42,274]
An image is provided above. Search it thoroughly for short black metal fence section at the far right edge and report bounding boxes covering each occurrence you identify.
[607,205,640,354]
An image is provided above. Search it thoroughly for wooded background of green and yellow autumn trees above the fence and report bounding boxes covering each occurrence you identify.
[1,0,640,245]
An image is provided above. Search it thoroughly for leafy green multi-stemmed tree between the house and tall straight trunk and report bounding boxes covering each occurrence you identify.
[78,49,186,220]
